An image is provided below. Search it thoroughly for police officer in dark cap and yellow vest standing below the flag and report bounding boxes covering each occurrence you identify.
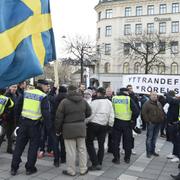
[11,80,51,175]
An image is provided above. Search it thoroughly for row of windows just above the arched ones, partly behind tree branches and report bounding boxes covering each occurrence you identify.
[97,41,179,55]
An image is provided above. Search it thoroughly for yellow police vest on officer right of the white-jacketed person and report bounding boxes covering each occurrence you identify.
[112,95,132,121]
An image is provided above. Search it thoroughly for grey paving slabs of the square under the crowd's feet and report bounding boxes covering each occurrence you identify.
[0,132,179,180]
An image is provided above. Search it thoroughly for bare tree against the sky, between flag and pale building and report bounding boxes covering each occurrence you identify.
[64,36,95,83]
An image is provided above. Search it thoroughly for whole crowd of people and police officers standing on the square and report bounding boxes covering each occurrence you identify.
[0,79,180,180]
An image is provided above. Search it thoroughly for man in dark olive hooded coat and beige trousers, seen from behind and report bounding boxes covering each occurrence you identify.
[55,85,91,176]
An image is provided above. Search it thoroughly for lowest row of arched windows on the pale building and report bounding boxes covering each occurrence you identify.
[104,62,178,74]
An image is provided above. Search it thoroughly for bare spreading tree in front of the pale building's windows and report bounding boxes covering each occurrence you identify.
[118,32,176,74]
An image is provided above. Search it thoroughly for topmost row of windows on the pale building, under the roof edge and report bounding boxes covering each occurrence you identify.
[98,3,180,21]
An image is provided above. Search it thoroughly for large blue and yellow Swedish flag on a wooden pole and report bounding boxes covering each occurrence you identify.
[0,0,56,88]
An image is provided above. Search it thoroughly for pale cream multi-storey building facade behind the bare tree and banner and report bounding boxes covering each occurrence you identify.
[95,0,180,88]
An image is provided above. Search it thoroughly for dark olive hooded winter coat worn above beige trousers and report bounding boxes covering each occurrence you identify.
[55,92,91,139]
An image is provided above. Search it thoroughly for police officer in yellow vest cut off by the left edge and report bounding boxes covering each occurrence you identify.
[0,89,14,149]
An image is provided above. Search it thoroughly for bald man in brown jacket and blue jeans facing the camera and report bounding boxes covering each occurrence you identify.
[142,92,164,158]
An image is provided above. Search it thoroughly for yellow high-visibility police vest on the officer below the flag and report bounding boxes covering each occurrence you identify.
[21,89,46,120]
